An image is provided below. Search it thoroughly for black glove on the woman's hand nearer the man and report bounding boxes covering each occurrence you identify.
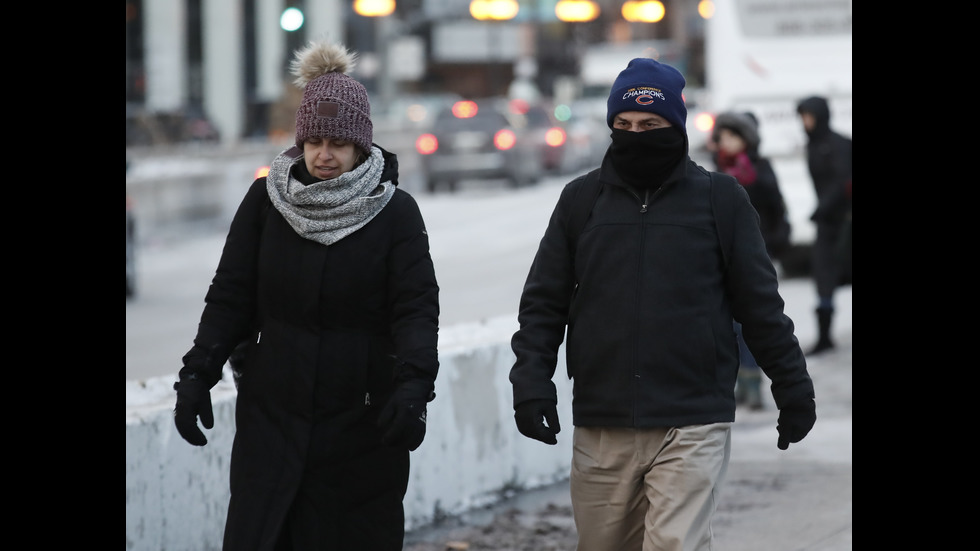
[378,378,436,451]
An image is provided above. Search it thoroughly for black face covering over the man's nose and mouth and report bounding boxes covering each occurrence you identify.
[609,126,686,189]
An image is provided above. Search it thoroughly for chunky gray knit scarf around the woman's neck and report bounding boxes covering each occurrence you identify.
[266,147,395,245]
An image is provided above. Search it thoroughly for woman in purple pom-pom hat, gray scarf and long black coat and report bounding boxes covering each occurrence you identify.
[174,42,439,551]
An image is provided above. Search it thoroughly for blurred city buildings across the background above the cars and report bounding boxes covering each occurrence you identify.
[126,0,704,146]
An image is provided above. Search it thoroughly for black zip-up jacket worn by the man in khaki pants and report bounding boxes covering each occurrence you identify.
[510,154,813,428]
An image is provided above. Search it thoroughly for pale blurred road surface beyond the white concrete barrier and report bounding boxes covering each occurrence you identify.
[126,153,812,381]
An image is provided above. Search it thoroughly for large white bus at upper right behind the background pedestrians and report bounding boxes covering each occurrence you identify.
[704,0,851,157]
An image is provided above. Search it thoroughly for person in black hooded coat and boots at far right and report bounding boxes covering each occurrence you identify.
[796,96,851,355]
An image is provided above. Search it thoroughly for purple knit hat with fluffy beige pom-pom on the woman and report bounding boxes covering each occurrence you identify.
[290,42,374,152]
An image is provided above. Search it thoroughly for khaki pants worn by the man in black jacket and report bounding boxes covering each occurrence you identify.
[570,423,732,551]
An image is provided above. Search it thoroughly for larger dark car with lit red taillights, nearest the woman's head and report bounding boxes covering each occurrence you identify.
[415,99,545,192]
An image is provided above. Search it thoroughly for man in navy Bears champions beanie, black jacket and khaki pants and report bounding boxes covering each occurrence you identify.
[510,58,816,551]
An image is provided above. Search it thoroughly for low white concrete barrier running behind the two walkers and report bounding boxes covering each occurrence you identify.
[126,315,572,551]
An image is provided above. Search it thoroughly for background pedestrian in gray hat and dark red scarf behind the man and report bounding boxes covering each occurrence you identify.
[711,112,791,410]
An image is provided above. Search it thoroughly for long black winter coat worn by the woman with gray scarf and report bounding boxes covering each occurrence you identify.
[185,146,439,551]
